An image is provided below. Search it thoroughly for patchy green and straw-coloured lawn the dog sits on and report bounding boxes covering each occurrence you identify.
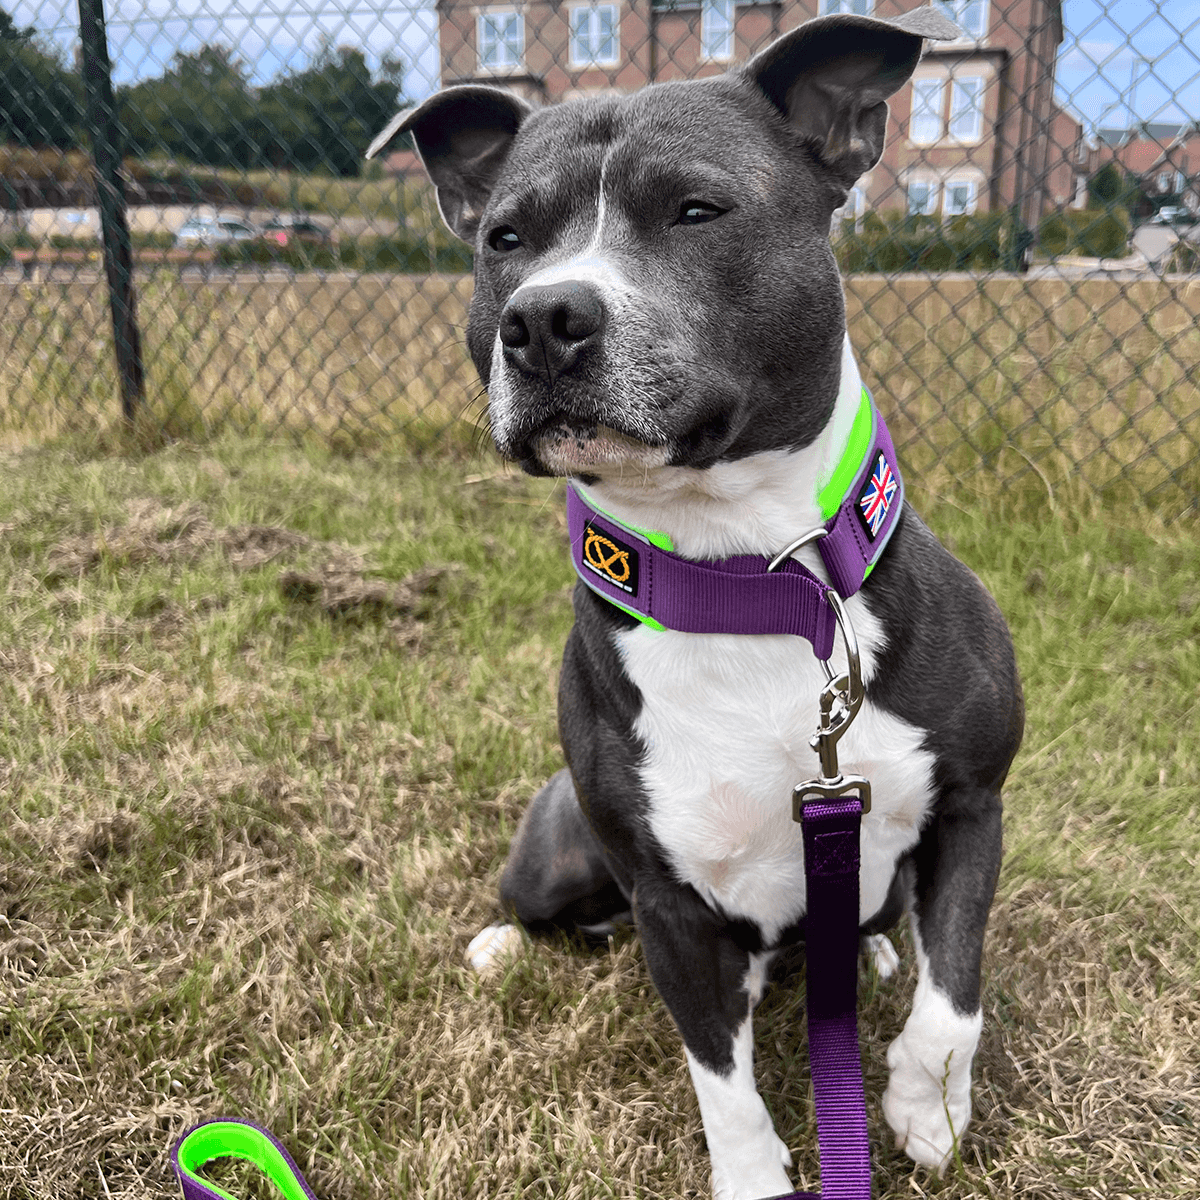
[0,440,1200,1200]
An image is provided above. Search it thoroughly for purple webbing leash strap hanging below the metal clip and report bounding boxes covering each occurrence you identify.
[786,797,871,1200]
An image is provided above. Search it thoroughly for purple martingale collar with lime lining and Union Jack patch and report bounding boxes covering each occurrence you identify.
[566,388,904,659]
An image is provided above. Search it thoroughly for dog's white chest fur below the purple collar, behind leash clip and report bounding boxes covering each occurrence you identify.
[617,596,934,943]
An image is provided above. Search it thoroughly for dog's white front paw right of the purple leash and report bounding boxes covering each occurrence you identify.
[883,1006,983,1171]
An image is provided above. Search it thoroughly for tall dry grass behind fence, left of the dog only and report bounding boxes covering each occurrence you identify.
[0,271,480,446]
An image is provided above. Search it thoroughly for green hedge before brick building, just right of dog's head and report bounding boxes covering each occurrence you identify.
[834,212,1006,274]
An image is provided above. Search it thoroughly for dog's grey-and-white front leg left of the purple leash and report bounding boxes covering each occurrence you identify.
[634,880,792,1200]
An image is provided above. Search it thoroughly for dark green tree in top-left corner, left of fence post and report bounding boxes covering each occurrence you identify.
[0,8,83,149]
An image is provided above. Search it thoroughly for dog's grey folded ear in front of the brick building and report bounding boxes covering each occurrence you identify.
[739,6,962,191]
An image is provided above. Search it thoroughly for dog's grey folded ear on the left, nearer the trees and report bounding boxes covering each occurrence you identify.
[366,84,533,241]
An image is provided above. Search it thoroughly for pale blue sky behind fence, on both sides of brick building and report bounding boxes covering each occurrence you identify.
[9,0,1200,132]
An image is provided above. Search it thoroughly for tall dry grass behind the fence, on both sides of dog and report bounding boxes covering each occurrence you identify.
[0,272,1200,515]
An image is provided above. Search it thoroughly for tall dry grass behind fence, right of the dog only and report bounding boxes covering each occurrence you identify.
[846,276,1200,511]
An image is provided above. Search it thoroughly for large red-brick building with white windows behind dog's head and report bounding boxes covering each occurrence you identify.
[437,0,1085,226]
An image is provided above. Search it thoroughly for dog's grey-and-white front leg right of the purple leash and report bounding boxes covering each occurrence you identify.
[883,788,1001,1170]
